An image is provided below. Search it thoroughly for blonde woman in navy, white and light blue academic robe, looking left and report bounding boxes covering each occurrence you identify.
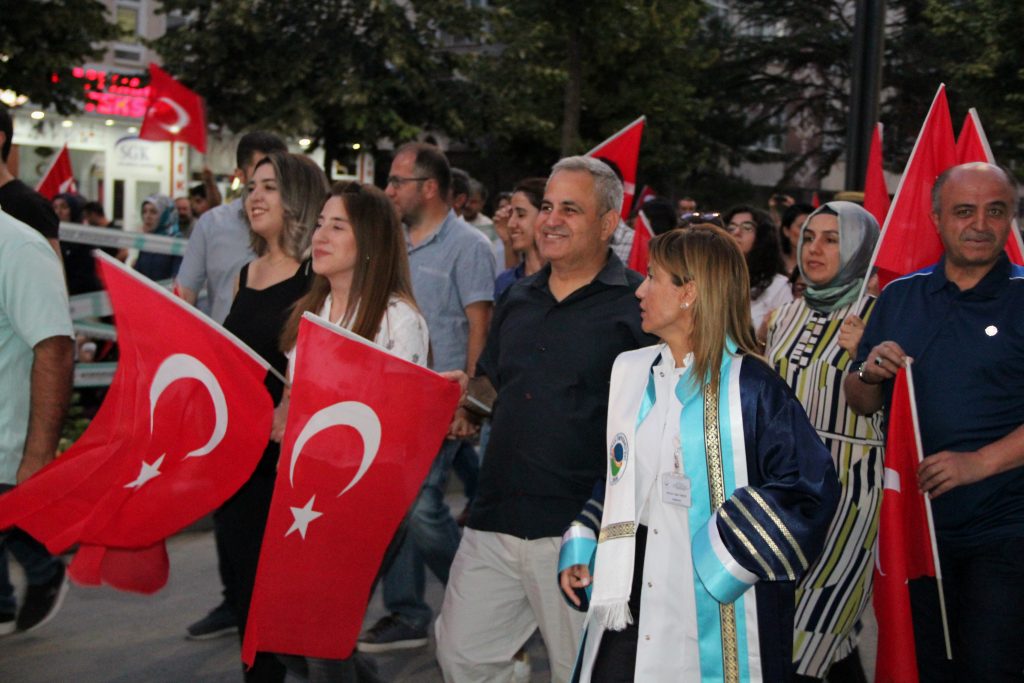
[559,227,839,681]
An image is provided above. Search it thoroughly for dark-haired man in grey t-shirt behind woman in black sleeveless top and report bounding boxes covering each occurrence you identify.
[177,131,288,323]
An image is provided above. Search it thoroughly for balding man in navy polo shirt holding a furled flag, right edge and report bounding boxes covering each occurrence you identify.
[845,163,1024,681]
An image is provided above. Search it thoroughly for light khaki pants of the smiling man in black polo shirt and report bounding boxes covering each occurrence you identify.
[434,528,584,683]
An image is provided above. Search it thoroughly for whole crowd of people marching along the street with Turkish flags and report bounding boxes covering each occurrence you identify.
[0,96,1024,682]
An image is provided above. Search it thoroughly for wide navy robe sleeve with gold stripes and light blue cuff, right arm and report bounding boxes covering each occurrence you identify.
[693,369,840,603]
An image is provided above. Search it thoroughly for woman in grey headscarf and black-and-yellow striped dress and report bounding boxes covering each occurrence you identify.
[766,202,884,681]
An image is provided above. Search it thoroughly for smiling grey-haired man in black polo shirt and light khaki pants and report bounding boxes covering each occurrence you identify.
[435,157,655,681]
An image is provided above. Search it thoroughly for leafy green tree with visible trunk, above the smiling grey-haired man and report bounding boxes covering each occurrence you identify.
[460,0,746,200]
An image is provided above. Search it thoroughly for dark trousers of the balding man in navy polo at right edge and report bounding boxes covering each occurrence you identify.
[910,539,1024,683]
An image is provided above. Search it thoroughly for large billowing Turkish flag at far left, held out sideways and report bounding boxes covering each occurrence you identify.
[0,252,273,590]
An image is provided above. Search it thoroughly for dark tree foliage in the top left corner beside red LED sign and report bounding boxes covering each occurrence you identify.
[0,0,117,114]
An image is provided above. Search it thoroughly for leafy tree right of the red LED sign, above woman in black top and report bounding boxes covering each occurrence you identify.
[154,0,478,176]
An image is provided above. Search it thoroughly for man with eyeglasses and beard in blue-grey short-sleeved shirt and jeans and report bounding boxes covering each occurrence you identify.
[357,142,496,652]
